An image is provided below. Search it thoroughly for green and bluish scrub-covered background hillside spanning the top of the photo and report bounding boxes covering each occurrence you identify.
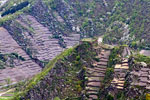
[1,0,149,49]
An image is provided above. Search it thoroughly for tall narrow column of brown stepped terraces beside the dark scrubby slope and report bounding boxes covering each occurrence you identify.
[86,50,110,100]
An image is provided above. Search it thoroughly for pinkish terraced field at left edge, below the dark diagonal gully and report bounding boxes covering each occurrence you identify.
[0,27,41,85]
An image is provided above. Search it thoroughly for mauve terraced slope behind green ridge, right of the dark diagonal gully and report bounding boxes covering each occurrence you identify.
[16,15,80,61]
